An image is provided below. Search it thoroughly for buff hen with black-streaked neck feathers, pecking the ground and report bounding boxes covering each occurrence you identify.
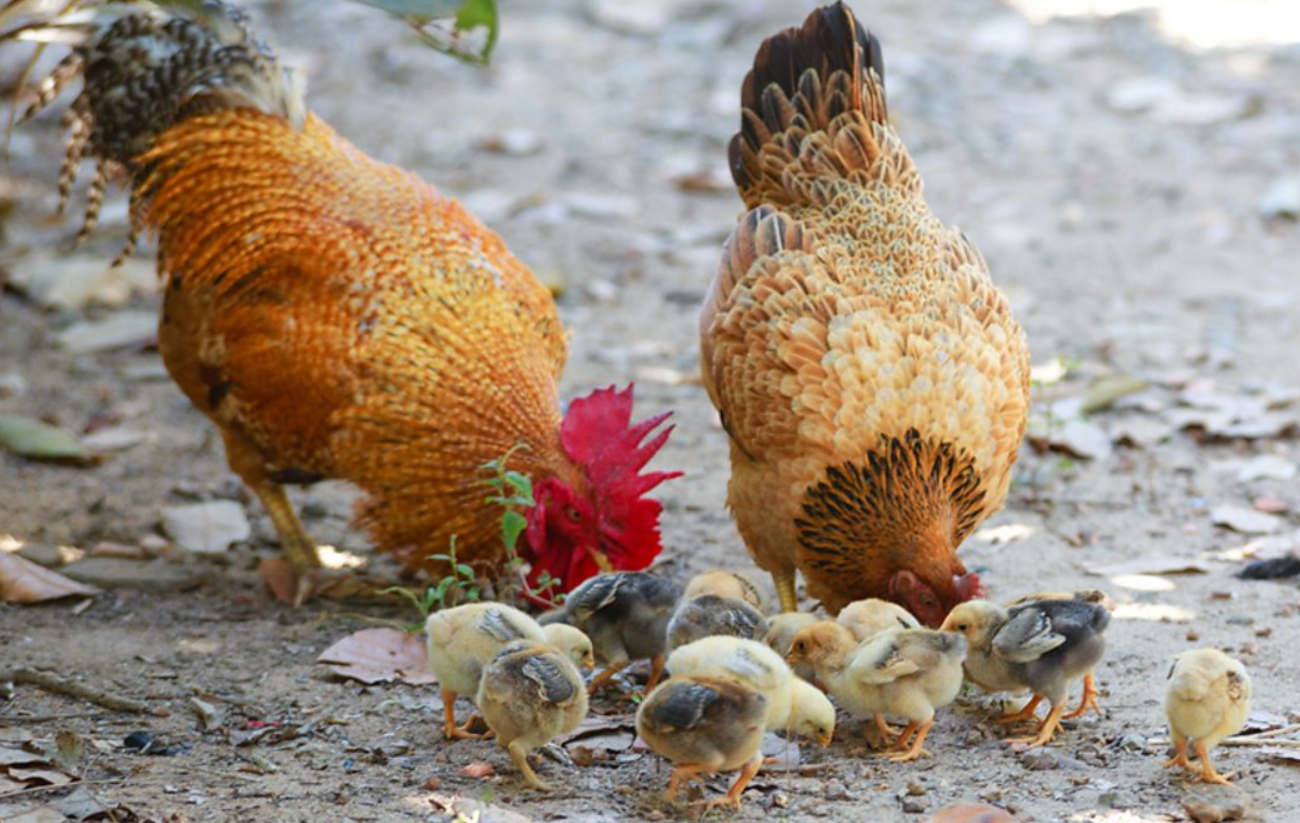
[699,3,1030,627]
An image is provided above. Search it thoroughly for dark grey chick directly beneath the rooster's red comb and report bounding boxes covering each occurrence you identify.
[541,572,681,692]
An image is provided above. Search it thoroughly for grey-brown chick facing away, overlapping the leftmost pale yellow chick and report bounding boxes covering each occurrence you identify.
[475,644,586,790]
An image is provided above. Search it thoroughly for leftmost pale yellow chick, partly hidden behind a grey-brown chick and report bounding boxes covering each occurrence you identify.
[424,603,546,740]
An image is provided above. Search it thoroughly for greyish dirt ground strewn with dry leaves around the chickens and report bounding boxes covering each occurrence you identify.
[0,0,1300,823]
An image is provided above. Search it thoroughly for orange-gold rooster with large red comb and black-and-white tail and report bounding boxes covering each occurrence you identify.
[15,3,676,594]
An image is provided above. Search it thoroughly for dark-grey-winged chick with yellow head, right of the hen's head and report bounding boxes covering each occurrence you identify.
[940,599,1110,748]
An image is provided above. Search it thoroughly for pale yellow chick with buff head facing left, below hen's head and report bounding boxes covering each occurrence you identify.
[787,620,966,761]
